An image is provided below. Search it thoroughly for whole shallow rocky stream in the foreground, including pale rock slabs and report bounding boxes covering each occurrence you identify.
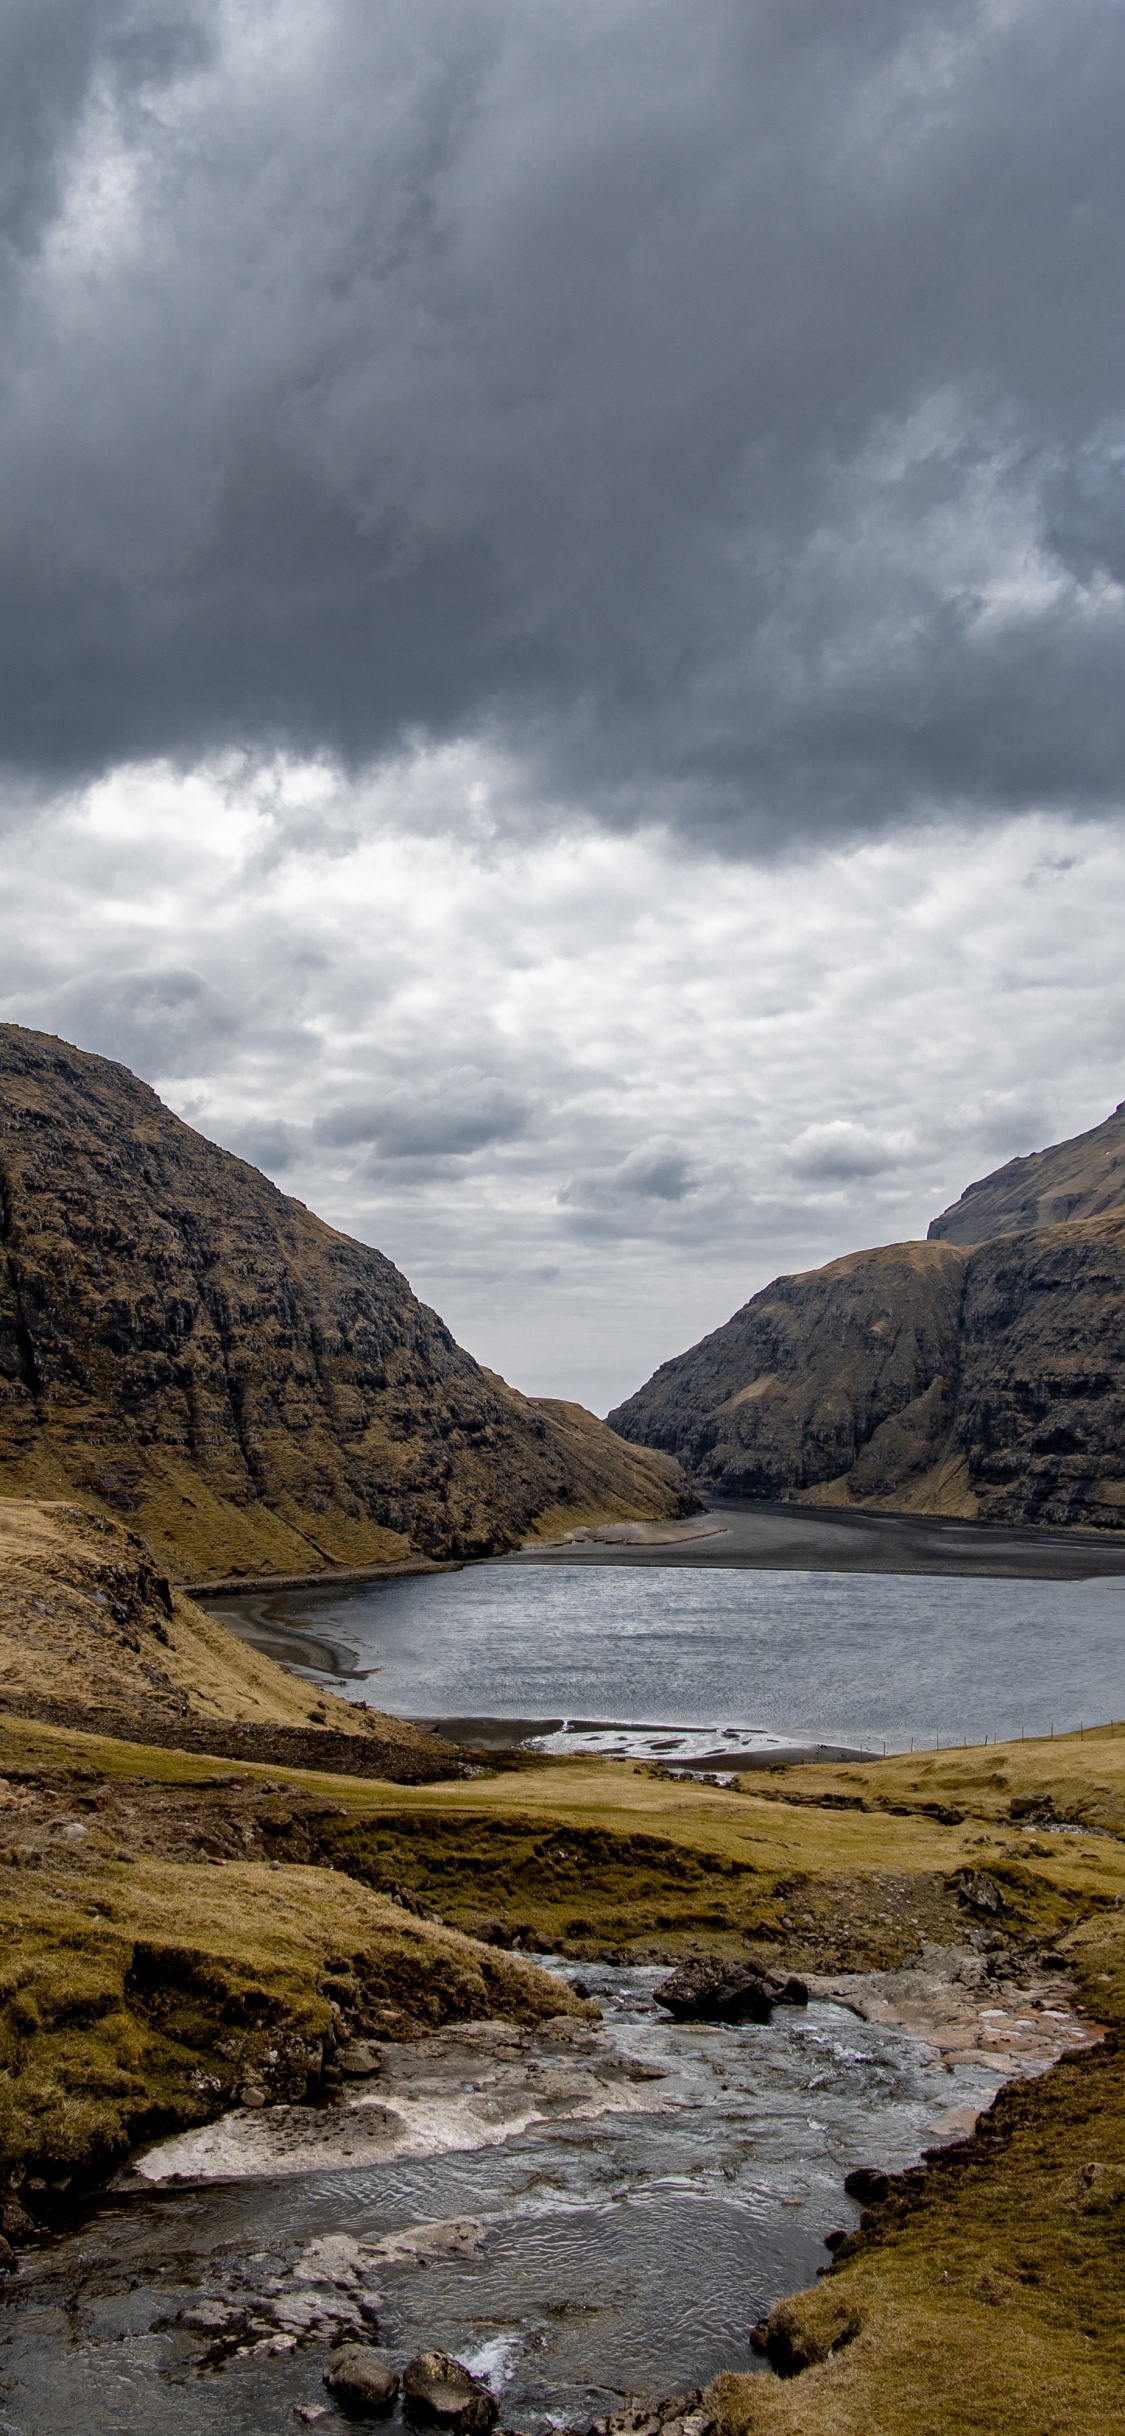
[0,1966,1027,2436]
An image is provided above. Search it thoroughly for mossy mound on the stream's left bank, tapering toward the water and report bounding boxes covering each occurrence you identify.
[0,1861,582,2180]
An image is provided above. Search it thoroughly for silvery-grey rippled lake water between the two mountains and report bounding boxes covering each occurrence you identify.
[212,1559,1125,1751]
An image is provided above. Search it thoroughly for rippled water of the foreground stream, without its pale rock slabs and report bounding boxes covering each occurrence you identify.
[0,1966,1012,2436]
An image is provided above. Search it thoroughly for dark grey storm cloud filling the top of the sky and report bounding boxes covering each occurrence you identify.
[0,0,1125,843]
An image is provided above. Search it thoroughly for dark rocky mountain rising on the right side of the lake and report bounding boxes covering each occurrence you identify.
[609,1108,1125,1530]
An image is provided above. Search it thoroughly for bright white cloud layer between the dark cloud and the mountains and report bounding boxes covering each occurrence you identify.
[0,743,1125,1410]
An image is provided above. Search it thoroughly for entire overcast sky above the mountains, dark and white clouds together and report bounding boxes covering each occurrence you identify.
[0,0,1125,1408]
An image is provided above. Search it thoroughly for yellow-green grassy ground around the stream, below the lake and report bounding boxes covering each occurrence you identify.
[0,1717,1125,2436]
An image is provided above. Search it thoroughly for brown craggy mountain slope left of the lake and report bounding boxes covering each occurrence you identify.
[0,1023,684,1581]
